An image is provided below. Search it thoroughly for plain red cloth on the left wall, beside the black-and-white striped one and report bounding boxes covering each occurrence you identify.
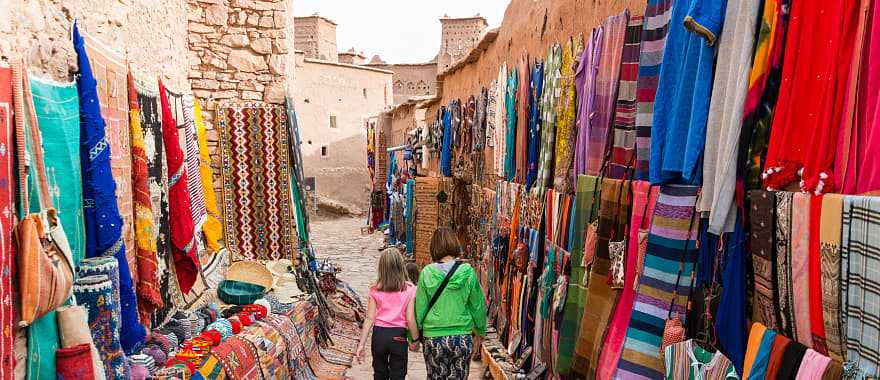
[159,80,199,294]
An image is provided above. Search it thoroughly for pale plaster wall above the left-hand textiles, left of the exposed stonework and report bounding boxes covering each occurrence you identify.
[0,0,189,92]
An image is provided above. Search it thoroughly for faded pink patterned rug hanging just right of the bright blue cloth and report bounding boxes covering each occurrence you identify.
[82,32,137,280]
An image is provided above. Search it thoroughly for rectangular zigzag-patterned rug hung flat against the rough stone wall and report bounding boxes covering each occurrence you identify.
[217,103,295,260]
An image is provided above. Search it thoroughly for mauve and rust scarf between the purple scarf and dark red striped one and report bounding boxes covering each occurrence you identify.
[579,9,630,175]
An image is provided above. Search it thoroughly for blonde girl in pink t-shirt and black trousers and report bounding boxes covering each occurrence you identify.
[357,250,419,380]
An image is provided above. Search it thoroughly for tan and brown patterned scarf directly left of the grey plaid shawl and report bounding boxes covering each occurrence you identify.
[810,194,844,363]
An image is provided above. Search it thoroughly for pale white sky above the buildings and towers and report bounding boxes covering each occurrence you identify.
[293,0,509,63]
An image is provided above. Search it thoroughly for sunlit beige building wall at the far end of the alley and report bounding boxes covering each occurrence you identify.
[294,52,393,207]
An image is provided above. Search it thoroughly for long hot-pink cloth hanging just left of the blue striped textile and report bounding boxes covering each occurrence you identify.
[596,181,657,379]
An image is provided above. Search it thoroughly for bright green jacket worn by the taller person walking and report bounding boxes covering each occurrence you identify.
[415,264,486,338]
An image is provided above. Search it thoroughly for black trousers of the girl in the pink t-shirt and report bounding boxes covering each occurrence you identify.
[370,326,409,380]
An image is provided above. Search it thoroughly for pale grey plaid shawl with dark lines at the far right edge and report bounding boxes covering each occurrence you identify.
[840,197,880,378]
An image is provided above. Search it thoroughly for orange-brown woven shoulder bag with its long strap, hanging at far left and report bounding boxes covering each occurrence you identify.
[13,64,73,326]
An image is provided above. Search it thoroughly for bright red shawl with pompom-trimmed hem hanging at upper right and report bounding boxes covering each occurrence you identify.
[764,0,859,193]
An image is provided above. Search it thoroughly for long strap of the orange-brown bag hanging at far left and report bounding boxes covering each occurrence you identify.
[13,62,52,214]
